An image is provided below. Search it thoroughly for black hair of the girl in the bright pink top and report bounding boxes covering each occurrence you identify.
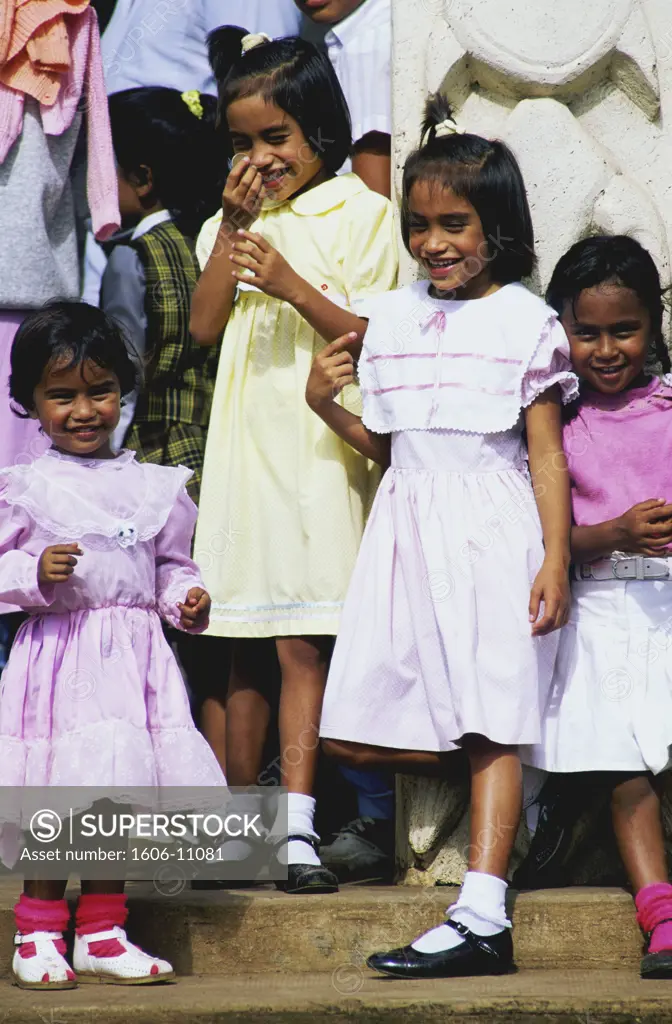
[546,234,672,374]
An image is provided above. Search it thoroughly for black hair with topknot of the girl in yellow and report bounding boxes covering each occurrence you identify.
[208,25,352,174]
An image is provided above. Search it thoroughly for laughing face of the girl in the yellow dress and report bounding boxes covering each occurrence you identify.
[226,95,327,202]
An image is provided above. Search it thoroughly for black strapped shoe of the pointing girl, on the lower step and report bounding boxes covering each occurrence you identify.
[367,921,515,978]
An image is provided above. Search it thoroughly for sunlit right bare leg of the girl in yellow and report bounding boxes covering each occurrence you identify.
[276,637,332,796]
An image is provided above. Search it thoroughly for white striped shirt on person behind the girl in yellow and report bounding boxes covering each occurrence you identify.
[325,0,392,142]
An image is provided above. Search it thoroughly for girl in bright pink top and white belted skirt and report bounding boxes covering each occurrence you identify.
[521,237,672,978]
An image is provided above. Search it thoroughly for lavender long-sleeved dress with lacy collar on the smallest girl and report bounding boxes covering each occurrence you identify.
[0,449,224,786]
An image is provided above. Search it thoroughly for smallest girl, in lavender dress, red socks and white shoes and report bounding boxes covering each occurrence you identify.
[0,302,224,989]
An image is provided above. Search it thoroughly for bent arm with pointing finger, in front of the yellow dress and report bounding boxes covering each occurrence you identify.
[305,333,390,468]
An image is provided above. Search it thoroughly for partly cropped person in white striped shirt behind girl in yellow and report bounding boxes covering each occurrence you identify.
[295,0,392,198]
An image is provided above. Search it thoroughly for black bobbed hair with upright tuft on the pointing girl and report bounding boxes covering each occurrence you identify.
[402,93,536,285]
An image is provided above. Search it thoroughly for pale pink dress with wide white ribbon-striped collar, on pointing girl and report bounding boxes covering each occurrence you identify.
[321,283,578,751]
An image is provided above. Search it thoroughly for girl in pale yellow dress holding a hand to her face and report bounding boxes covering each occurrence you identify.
[191,28,397,892]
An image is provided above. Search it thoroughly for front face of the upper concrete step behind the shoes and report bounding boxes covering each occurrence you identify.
[0,880,647,974]
